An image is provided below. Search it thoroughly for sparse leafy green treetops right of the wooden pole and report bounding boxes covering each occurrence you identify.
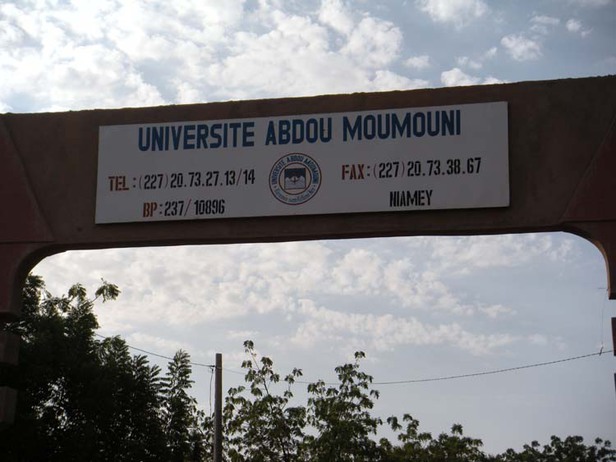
[219,341,616,462]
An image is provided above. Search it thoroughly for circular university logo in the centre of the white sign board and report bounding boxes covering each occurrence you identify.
[269,152,321,205]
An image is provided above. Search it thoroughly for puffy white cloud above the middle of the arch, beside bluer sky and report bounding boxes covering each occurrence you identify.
[197,2,412,98]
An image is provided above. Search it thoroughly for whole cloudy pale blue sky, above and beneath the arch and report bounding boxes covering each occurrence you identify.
[0,0,616,451]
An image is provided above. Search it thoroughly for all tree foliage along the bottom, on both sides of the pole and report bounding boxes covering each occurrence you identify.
[0,276,616,462]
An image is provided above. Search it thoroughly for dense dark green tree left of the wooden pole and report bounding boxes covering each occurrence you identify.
[0,275,202,462]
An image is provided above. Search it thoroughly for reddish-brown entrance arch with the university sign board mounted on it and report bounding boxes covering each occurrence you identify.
[0,76,616,425]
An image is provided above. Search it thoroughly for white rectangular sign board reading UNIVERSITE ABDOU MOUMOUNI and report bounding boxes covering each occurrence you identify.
[96,102,509,223]
